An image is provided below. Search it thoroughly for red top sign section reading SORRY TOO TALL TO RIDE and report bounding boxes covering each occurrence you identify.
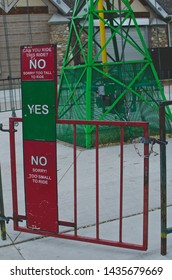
[21,45,57,81]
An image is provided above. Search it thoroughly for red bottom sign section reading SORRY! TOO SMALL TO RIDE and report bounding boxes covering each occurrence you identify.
[24,140,58,232]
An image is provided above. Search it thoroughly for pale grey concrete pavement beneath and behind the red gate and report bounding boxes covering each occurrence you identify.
[0,112,172,260]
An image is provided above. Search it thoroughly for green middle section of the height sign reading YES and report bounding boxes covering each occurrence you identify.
[22,81,56,141]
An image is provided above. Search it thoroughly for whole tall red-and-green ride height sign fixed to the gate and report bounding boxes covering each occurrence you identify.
[21,45,58,232]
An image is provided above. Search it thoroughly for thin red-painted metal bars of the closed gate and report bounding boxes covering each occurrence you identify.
[10,118,149,250]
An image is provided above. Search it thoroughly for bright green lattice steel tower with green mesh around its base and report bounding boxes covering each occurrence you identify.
[58,0,172,147]
